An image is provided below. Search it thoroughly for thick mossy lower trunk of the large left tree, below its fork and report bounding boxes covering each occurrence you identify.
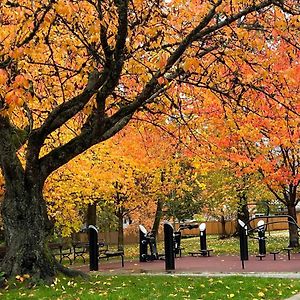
[1,179,56,279]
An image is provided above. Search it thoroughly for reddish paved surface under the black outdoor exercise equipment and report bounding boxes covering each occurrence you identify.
[74,253,300,277]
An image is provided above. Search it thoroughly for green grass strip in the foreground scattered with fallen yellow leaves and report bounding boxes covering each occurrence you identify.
[0,275,300,300]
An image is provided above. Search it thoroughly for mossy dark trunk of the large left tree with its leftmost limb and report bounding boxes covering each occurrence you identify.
[0,117,56,279]
